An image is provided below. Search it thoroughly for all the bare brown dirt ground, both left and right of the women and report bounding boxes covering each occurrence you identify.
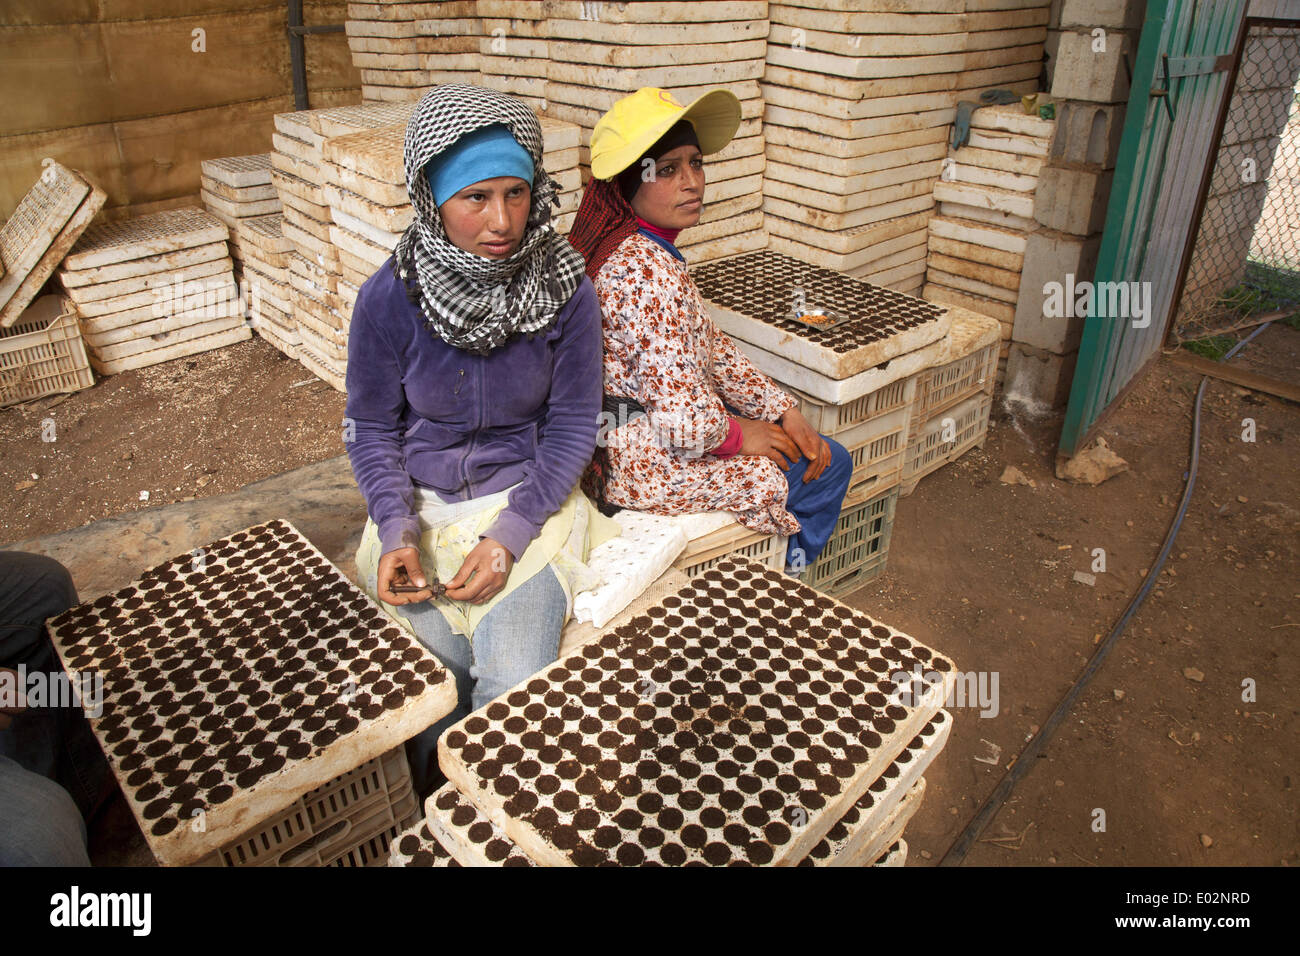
[0,329,1300,866]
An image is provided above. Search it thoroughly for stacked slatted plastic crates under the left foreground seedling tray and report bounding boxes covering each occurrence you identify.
[196,747,413,866]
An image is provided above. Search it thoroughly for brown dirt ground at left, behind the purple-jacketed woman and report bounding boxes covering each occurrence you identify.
[0,336,345,541]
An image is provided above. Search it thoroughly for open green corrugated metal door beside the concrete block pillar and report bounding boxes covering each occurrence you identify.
[1060,0,1247,455]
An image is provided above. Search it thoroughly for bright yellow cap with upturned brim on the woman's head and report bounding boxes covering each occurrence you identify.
[592,86,740,179]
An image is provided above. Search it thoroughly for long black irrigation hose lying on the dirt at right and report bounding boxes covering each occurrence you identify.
[939,323,1270,866]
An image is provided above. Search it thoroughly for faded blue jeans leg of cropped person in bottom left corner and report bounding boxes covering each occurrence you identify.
[0,757,90,866]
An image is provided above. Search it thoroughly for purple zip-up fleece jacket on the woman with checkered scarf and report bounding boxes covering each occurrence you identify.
[346,259,603,559]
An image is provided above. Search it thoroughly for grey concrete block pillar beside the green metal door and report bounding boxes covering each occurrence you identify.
[1002,0,1147,406]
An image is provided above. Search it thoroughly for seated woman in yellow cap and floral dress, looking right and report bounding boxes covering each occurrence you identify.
[569,87,852,572]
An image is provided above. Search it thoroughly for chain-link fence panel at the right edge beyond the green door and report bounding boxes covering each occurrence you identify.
[1170,25,1300,342]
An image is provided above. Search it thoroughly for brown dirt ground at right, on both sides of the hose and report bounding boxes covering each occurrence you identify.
[850,326,1300,866]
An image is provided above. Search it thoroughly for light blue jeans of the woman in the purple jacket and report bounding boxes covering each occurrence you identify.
[395,566,568,796]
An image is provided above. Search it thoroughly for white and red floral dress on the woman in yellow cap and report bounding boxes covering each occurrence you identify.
[595,233,800,535]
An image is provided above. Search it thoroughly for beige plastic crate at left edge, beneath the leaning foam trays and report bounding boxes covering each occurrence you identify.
[0,295,95,408]
